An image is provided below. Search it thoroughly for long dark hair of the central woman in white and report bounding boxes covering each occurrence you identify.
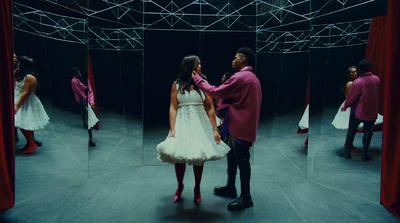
[176,55,200,94]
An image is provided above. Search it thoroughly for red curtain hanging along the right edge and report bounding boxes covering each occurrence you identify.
[381,0,400,217]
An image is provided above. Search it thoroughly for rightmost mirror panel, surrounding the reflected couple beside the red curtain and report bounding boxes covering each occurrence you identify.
[308,1,387,202]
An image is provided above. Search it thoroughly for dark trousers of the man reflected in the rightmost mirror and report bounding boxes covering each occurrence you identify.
[345,114,375,153]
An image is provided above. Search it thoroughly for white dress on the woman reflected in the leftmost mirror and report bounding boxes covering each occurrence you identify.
[14,75,50,131]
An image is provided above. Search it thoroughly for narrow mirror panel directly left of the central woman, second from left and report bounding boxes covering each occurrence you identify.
[88,1,143,176]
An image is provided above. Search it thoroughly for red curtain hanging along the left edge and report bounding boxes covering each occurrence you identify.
[0,1,15,212]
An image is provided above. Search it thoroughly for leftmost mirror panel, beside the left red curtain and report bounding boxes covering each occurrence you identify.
[14,0,88,201]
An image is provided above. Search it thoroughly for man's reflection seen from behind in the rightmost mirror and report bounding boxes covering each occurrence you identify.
[338,60,380,162]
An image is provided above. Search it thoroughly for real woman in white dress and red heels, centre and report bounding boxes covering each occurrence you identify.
[157,56,230,204]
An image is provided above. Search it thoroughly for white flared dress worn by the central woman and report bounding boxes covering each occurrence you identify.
[157,85,230,165]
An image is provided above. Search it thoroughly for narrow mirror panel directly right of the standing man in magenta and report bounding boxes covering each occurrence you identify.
[256,1,310,181]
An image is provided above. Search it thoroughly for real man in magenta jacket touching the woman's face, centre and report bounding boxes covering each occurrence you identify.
[193,47,262,211]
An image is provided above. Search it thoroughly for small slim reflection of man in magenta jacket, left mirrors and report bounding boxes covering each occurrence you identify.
[71,67,96,146]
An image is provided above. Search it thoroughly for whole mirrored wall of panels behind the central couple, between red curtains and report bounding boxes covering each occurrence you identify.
[14,0,387,206]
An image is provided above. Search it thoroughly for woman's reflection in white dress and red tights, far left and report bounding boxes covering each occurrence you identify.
[14,56,49,154]
